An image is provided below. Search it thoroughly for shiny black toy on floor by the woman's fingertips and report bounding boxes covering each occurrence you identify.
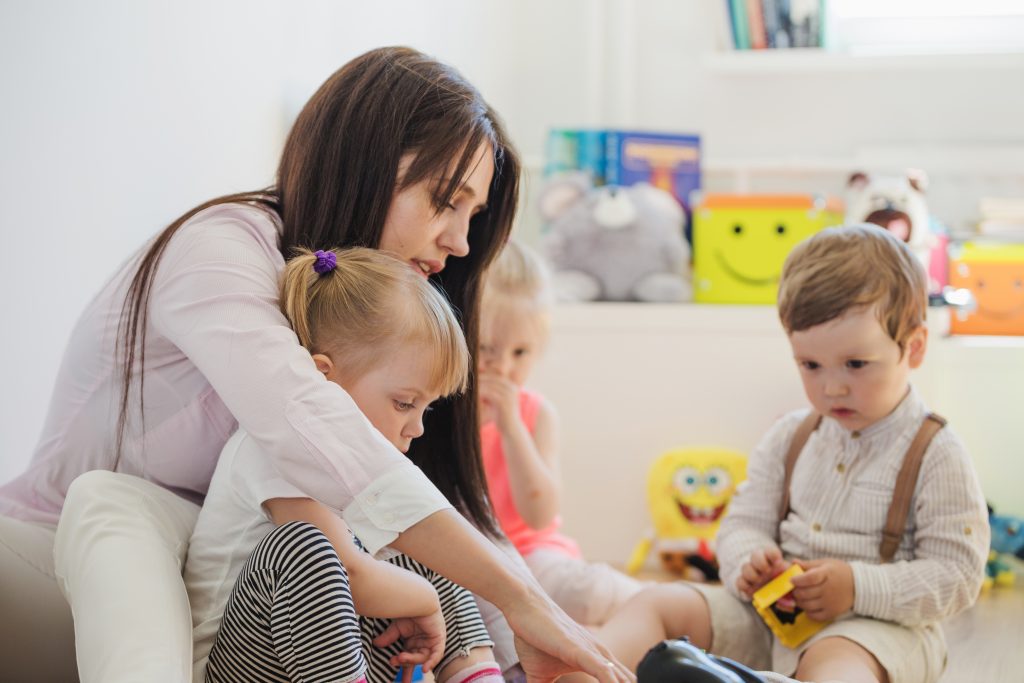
[637,638,765,683]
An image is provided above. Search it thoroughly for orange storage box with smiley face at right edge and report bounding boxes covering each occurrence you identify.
[949,242,1024,335]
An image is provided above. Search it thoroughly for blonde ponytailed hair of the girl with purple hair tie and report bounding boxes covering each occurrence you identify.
[281,248,469,396]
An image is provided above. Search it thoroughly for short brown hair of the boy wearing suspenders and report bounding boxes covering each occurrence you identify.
[778,224,928,352]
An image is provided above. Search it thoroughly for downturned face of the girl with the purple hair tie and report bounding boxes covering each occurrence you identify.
[313,346,438,453]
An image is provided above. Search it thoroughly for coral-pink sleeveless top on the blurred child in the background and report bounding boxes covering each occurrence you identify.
[480,389,581,557]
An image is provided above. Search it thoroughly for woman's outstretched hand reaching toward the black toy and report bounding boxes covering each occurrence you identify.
[504,596,636,683]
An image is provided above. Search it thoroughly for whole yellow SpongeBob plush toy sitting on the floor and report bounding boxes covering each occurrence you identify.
[626,449,746,580]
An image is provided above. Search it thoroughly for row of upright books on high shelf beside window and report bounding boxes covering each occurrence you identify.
[721,0,824,50]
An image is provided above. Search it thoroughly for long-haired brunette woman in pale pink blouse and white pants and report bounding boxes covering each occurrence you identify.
[0,48,631,683]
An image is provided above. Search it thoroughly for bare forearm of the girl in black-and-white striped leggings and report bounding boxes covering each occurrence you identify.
[263,498,440,618]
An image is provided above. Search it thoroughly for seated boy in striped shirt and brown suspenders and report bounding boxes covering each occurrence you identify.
[602,225,989,683]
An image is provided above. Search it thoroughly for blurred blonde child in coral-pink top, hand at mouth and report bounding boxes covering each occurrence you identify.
[477,242,642,626]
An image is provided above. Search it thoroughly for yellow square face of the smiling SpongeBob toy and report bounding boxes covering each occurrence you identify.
[647,449,746,540]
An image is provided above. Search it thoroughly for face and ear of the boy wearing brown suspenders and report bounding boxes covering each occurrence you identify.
[790,307,928,430]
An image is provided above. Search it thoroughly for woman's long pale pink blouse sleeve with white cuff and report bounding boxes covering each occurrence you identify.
[148,205,451,553]
